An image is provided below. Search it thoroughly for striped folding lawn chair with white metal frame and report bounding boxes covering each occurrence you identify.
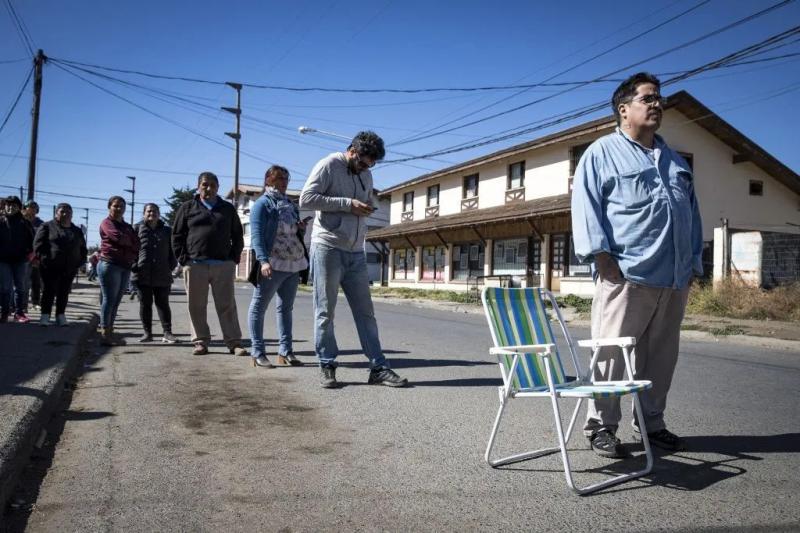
[481,287,653,494]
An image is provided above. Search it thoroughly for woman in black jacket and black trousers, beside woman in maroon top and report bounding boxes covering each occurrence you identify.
[132,203,178,344]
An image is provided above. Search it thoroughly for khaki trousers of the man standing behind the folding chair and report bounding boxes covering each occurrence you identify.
[584,279,689,436]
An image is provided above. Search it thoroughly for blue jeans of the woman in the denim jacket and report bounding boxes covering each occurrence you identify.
[247,271,300,357]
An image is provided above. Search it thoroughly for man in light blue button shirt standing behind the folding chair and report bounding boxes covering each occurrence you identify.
[572,72,703,458]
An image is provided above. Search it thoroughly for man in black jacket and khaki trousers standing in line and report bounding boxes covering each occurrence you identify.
[172,172,248,355]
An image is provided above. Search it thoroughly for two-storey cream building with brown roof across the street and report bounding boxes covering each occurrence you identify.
[367,91,800,295]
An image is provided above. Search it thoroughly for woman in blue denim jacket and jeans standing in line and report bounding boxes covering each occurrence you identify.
[248,165,308,368]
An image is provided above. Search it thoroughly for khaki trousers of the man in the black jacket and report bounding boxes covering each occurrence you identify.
[183,261,242,348]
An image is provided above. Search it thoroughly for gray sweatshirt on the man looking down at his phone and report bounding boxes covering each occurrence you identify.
[300,152,374,252]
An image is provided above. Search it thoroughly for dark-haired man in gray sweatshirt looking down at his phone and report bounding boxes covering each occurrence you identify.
[300,131,408,389]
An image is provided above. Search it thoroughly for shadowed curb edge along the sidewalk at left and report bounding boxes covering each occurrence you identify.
[0,313,99,516]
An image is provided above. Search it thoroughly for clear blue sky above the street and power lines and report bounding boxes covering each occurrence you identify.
[0,0,800,243]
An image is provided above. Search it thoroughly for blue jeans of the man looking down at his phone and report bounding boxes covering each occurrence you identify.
[311,244,389,368]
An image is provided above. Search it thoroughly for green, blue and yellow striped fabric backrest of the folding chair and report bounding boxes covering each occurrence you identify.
[483,287,565,390]
